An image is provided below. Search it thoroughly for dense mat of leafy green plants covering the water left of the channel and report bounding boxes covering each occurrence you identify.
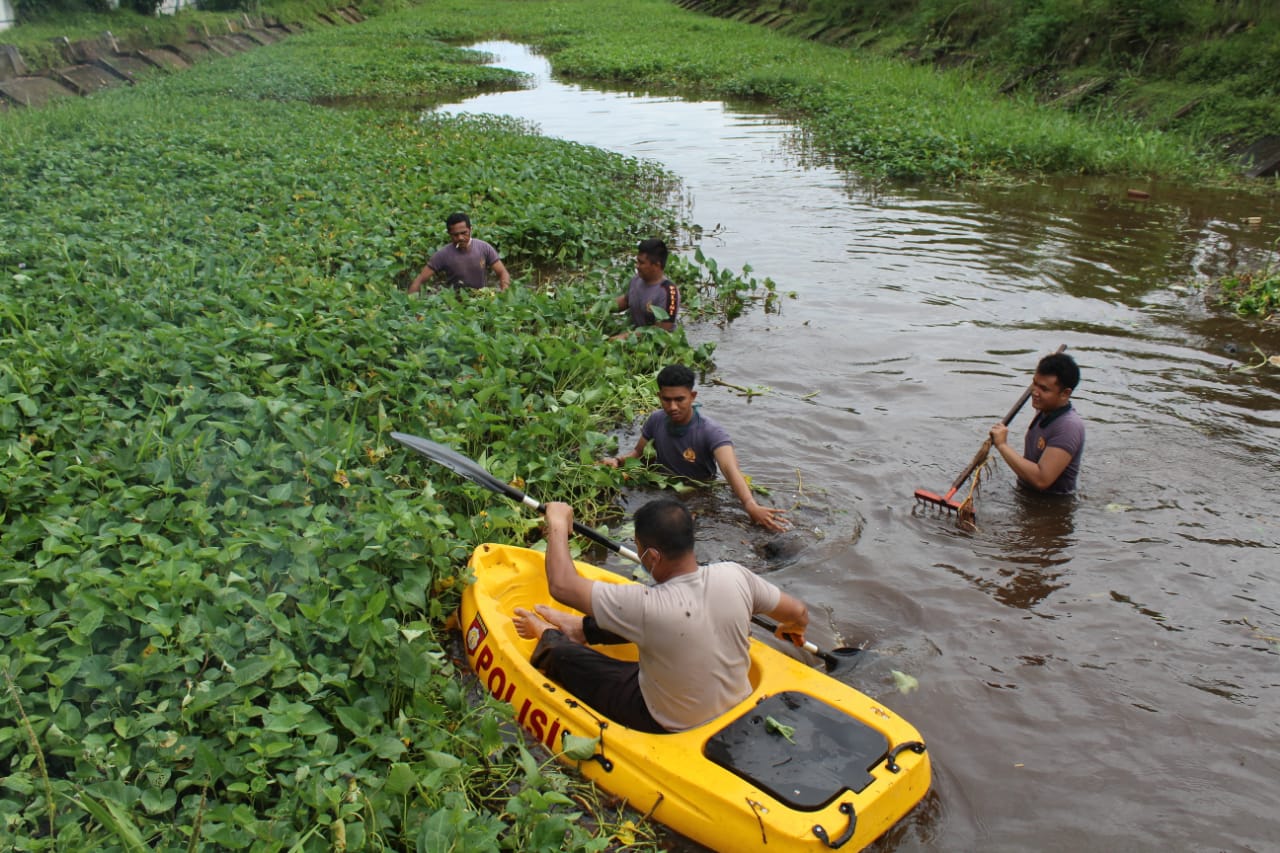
[0,9,778,852]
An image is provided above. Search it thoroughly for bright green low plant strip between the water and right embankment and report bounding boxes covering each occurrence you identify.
[7,0,1249,181]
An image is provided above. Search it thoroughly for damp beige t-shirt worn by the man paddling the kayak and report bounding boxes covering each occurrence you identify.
[591,562,782,731]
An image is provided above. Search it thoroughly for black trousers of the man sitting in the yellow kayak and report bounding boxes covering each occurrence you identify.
[530,617,667,734]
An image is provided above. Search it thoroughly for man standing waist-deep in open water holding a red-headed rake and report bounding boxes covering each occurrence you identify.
[991,352,1084,494]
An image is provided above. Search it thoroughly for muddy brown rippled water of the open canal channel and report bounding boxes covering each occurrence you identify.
[435,42,1280,852]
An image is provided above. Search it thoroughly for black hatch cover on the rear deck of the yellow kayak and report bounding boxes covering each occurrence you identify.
[705,690,888,811]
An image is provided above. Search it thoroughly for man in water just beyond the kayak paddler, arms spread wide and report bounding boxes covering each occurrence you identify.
[602,364,790,533]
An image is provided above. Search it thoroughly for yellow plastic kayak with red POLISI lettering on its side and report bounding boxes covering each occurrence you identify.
[460,544,931,853]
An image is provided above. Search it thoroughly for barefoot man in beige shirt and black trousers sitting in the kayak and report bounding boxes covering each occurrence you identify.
[515,498,809,733]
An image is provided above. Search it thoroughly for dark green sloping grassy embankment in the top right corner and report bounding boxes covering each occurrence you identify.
[732,0,1280,154]
